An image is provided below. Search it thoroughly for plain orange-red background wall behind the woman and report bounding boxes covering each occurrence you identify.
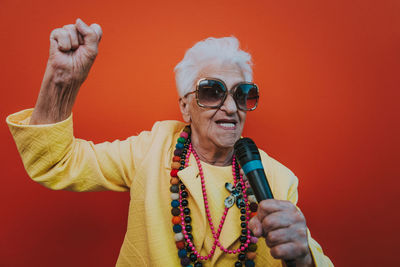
[0,0,400,266]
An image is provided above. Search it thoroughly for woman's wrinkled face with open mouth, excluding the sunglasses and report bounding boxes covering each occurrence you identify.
[181,63,246,150]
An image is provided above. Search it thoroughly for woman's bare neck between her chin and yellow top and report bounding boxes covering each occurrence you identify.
[192,136,233,166]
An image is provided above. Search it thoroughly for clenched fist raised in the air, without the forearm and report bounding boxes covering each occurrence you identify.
[48,19,102,85]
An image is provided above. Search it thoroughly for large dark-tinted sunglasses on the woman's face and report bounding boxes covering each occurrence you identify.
[184,78,259,111]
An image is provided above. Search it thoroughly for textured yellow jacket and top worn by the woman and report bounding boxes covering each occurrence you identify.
[7,110,333,266]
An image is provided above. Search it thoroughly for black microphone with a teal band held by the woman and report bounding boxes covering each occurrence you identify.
[234,137,296,267]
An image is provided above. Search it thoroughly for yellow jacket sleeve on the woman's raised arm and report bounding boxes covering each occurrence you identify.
[6,109,141,192]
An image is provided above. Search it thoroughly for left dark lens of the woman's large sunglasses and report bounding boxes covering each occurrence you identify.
[197,80,226,107]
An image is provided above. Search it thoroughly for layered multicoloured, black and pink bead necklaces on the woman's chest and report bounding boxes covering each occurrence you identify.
[170,125,258,267]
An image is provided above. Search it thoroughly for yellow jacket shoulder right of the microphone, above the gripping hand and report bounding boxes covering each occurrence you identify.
[259,149,298,200]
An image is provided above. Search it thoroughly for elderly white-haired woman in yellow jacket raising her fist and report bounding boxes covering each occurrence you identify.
[7,19,332,266]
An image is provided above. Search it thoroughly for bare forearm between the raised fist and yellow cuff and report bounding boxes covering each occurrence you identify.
[30,65,81,125]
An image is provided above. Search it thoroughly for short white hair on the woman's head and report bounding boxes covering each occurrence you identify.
[174,36,253,97]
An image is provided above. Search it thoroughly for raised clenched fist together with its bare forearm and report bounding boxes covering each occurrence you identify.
[30,19,102,124]
